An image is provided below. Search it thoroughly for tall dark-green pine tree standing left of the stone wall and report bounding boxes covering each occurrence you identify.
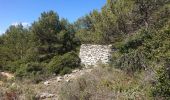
[31,11,80,62]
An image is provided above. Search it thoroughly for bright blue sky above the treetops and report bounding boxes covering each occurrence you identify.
[0,0,106,34]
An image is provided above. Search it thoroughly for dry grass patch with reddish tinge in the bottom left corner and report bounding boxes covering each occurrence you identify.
[0,80,35,100]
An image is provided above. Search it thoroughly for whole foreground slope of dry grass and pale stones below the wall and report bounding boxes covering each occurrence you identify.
[0,67,152,100]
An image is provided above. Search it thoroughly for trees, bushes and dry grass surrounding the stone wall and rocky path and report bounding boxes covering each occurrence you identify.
[0,0,170,100]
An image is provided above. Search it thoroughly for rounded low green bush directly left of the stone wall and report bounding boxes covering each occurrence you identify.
[48,52,80,74]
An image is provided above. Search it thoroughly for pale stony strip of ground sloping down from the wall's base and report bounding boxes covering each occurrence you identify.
[36,68,93,100]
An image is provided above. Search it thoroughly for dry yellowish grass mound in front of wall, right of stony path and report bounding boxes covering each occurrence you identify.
[60,67,151,100]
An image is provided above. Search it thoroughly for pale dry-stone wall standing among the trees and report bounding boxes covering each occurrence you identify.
[79,44,112,67]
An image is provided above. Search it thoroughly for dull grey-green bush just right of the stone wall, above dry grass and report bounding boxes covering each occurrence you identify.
[115,49,147,73]
